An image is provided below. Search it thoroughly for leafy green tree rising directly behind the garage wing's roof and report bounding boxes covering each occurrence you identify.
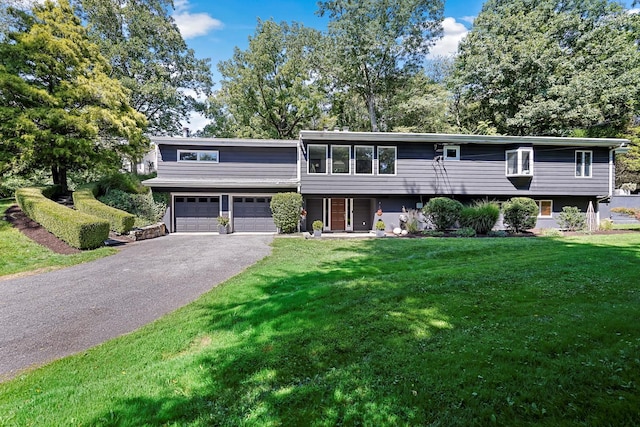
[210,20,323,138]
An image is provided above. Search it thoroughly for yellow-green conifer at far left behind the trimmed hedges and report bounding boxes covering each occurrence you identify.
[0,0,149,188]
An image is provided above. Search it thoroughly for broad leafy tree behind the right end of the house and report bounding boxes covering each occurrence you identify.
[454,0,640,136]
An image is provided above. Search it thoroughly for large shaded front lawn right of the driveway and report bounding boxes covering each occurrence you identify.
[0,234,640,426]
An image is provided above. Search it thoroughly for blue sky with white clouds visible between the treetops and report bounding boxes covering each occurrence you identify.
[173,0,633,130]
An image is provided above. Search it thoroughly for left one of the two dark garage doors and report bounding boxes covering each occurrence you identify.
[174,197,220,231]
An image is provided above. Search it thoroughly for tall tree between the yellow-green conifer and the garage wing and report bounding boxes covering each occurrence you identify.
[76,0,212,134]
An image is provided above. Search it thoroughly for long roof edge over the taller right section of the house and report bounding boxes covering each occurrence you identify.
[300,130,630,148]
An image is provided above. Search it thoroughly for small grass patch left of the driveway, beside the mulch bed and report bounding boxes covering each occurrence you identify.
[0,199,115,276]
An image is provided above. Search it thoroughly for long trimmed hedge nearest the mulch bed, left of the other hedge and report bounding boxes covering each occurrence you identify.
[16,188,109,249]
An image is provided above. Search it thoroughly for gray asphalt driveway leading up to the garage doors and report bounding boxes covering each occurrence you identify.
[0,234,273,380]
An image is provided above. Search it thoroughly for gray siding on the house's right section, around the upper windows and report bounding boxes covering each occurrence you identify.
[301,141,609,197]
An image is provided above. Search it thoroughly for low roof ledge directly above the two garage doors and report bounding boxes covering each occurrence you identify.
[142,177,298,188]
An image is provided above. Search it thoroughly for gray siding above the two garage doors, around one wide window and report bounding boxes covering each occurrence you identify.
[158,145,297,179]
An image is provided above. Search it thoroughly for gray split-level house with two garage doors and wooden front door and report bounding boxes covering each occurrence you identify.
[145,131,629,231]
